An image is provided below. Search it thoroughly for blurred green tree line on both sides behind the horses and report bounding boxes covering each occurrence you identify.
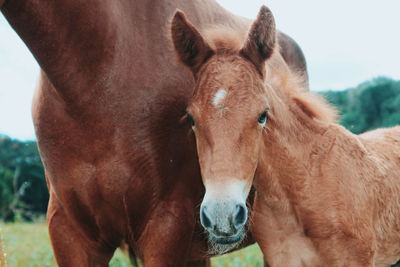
[0,78,400,222]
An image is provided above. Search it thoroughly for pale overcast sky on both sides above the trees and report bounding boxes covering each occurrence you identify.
[0,0,400,139]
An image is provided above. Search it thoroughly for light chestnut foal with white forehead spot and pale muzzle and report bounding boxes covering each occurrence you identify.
[172,7,400,266]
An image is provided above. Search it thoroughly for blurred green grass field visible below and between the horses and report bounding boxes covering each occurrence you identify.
[0,223,263,267]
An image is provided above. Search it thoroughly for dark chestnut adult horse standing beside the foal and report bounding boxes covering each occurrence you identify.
[0,0,306,267]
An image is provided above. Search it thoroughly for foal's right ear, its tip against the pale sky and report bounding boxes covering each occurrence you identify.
[240,6,276,75]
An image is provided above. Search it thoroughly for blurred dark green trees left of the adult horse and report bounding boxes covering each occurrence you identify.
[0,136,48,221]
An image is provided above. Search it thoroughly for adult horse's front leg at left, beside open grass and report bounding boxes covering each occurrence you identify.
[47,194,114,267]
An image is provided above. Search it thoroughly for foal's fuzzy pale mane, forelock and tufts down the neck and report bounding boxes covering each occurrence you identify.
[204,25,338,123]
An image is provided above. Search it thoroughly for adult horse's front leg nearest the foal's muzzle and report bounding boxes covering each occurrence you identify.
[139,201,195,267]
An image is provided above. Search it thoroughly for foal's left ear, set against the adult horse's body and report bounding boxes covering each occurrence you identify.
[171,10,214,74]
